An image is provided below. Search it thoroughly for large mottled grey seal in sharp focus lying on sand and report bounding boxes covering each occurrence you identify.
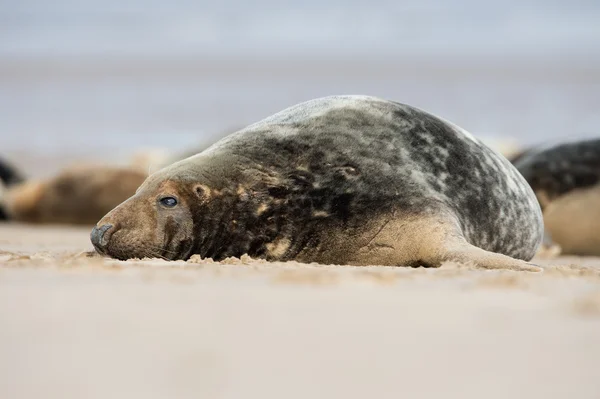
[91,96,543,270]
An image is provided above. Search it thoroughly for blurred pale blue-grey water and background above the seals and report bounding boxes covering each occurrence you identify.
[0,0,600,174]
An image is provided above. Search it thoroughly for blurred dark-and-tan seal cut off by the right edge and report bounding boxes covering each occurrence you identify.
[511,139,600,255]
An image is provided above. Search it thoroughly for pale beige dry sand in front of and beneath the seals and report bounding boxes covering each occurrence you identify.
[0,224,600,399]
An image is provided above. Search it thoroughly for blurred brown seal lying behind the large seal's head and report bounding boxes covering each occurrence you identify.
[3,165,147,225]
